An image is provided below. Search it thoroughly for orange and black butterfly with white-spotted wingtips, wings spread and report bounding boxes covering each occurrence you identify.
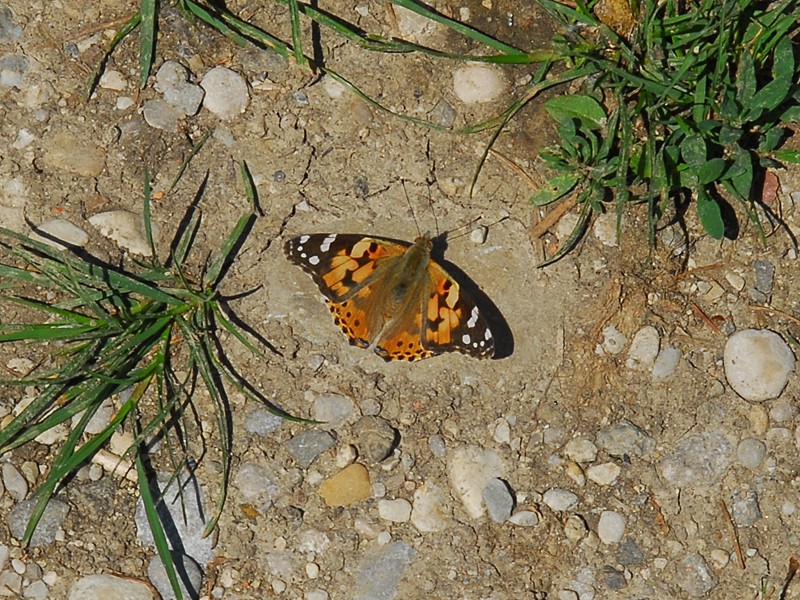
[284,233,494,361]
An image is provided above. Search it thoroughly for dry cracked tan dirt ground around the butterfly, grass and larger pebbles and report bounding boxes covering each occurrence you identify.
[0,0,800,600]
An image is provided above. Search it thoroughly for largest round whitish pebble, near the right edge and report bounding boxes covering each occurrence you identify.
[724,329,795,402]
